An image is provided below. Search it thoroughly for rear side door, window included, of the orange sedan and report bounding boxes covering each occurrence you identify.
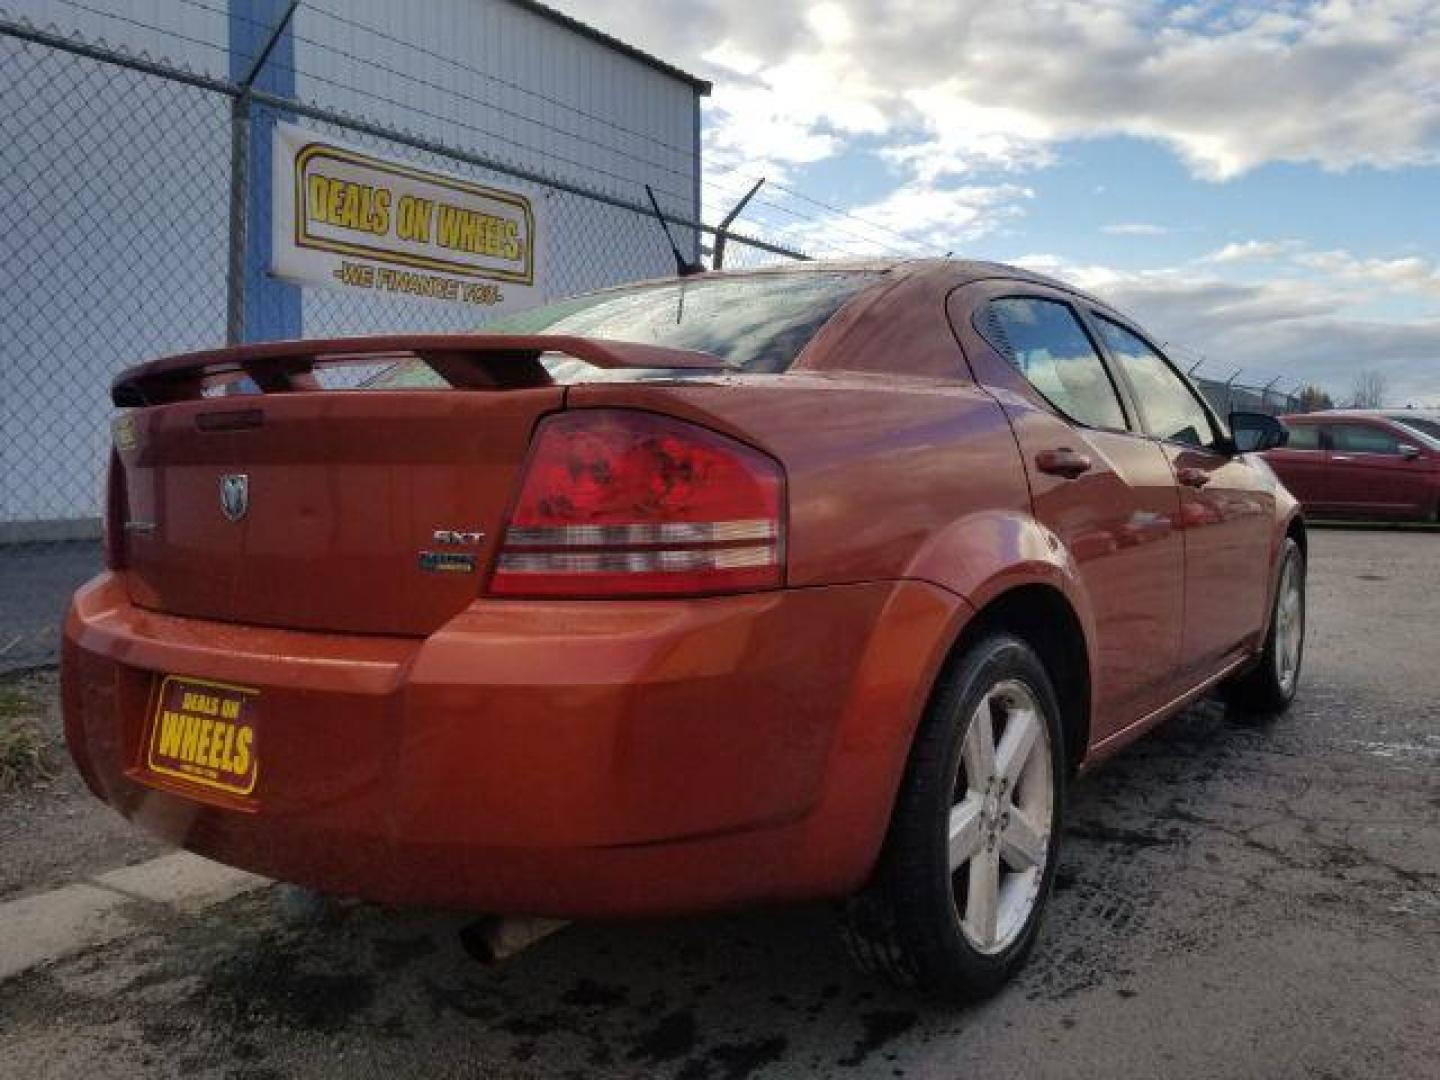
[949,281,1184,739]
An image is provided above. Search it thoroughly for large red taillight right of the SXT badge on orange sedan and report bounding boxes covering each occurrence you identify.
[490,409,785,596]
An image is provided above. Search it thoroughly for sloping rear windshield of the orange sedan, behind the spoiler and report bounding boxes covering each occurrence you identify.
[370,271,880,389]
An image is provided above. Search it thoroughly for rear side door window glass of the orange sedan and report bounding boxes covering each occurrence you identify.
[981,297,1126,431]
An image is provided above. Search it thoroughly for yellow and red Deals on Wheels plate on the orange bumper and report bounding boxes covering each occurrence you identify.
[145,675,261,798]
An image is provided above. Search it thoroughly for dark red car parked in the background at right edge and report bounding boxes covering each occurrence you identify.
[1264,409,1440,521]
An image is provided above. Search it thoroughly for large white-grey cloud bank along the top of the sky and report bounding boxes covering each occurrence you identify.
[555,0,1440,183]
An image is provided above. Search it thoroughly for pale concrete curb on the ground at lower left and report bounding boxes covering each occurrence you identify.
[0,851,269,982]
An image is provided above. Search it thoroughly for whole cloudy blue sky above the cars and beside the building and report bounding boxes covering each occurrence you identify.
[556,0,1440,408]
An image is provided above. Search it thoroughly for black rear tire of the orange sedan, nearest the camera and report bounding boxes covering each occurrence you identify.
[841,634,1067,1001]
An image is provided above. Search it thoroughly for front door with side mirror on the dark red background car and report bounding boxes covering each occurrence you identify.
[1325,420,1431,517]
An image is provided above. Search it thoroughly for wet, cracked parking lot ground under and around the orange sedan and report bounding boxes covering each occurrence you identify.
[0,530,1440,1080]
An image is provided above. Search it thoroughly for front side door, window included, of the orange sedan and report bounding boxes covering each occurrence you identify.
[1089,311,1276,677]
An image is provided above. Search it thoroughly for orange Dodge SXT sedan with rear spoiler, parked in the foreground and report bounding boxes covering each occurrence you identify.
[63,261,1305,995]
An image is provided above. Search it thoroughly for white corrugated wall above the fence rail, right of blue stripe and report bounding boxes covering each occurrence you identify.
[295,0,697,212]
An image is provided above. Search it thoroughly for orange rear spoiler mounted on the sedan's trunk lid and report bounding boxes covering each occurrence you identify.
[109,334,734,408]
